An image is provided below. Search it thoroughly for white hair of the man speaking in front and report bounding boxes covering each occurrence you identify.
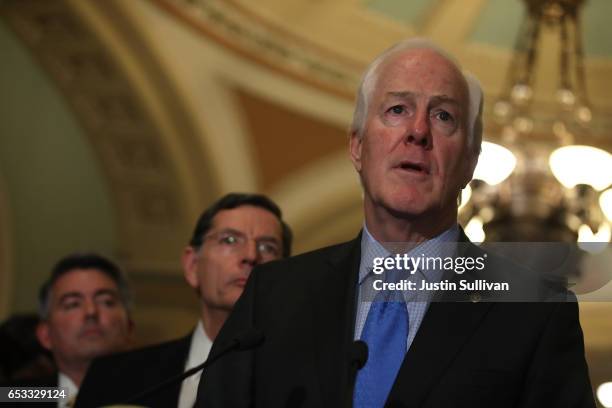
[350,38,483,156]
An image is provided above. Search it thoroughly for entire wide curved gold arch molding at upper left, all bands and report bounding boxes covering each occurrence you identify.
[0,0,218,273]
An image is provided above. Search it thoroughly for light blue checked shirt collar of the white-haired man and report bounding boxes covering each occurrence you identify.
[359,221,459,285]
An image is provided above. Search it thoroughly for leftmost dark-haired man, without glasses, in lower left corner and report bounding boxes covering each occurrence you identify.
[10,254,133,408]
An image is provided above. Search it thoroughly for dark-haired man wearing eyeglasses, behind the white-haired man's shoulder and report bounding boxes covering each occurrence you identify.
[76,193,292,408]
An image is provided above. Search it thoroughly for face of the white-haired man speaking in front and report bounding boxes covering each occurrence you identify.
[350,50,474,226]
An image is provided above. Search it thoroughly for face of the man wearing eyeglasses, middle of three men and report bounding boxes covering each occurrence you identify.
[183,205,282,311]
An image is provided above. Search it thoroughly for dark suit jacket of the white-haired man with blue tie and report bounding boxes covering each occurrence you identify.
[196,233,595,408]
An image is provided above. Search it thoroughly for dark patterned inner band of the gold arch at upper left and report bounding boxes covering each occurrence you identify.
[2,0,178,224]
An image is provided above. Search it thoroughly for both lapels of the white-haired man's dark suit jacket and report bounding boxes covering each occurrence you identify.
[309,228,492,407]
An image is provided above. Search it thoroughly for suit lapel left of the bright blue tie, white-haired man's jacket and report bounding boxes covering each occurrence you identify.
[310,234,361,406]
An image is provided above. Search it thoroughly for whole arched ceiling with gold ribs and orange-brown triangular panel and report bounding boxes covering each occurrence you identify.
[5,0,612,262]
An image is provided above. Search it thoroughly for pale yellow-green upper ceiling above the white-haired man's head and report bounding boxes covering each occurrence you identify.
[154,0,612,148]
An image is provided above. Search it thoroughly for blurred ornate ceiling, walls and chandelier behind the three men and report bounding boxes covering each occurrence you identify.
[0,0,612,404]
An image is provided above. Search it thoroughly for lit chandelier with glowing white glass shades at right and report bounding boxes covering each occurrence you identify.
[460,0,612,250]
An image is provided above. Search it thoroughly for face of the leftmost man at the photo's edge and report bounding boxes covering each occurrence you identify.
[37,269,133,369]
